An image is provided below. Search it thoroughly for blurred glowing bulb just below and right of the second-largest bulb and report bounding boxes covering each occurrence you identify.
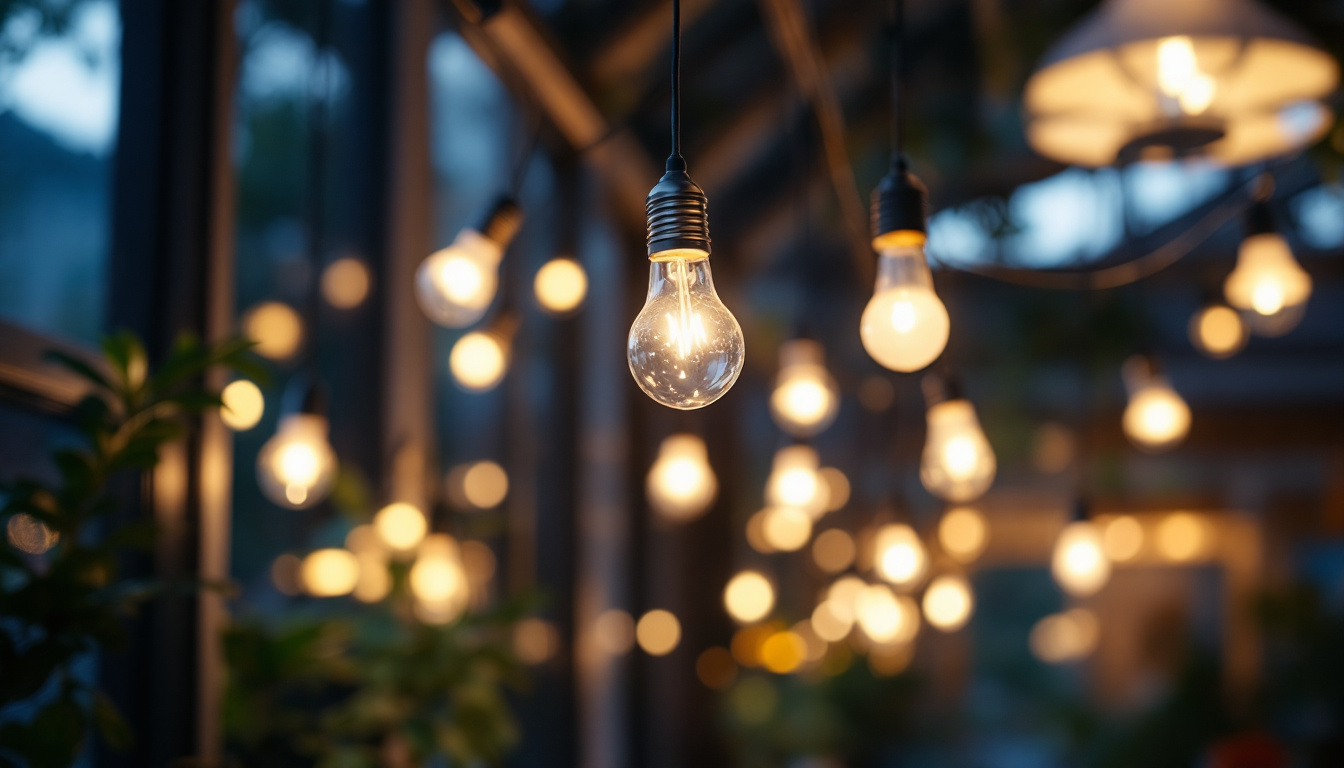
[919,399,997,503]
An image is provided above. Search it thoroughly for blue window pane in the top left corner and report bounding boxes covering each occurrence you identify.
[0,0,121,340]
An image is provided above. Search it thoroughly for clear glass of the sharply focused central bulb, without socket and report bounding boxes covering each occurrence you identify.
[626,250,746,410]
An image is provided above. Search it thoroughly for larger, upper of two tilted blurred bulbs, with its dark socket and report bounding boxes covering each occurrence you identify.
[415,196,523,328]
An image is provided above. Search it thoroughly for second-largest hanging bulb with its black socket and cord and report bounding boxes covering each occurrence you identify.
[859,0,950,373]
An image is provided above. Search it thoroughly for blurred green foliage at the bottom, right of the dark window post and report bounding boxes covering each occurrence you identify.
[224,604,523,768]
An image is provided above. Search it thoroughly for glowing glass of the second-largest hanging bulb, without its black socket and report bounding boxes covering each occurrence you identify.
[859,243,950,373]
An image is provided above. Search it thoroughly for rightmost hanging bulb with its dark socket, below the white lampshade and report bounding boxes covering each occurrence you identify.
[1223,202,1312,336]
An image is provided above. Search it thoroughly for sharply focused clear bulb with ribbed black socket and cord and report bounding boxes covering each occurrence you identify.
[626,0,746,410]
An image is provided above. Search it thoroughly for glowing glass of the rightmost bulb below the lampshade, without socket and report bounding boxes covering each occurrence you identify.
[1223,233,1312,335]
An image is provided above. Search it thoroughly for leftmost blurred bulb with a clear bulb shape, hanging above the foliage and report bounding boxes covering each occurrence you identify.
[257,413,336,510]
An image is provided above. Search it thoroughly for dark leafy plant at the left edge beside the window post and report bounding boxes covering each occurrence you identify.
[0,334,261,768]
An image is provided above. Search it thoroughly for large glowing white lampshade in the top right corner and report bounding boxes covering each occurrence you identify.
[1024,0,1339,167]
